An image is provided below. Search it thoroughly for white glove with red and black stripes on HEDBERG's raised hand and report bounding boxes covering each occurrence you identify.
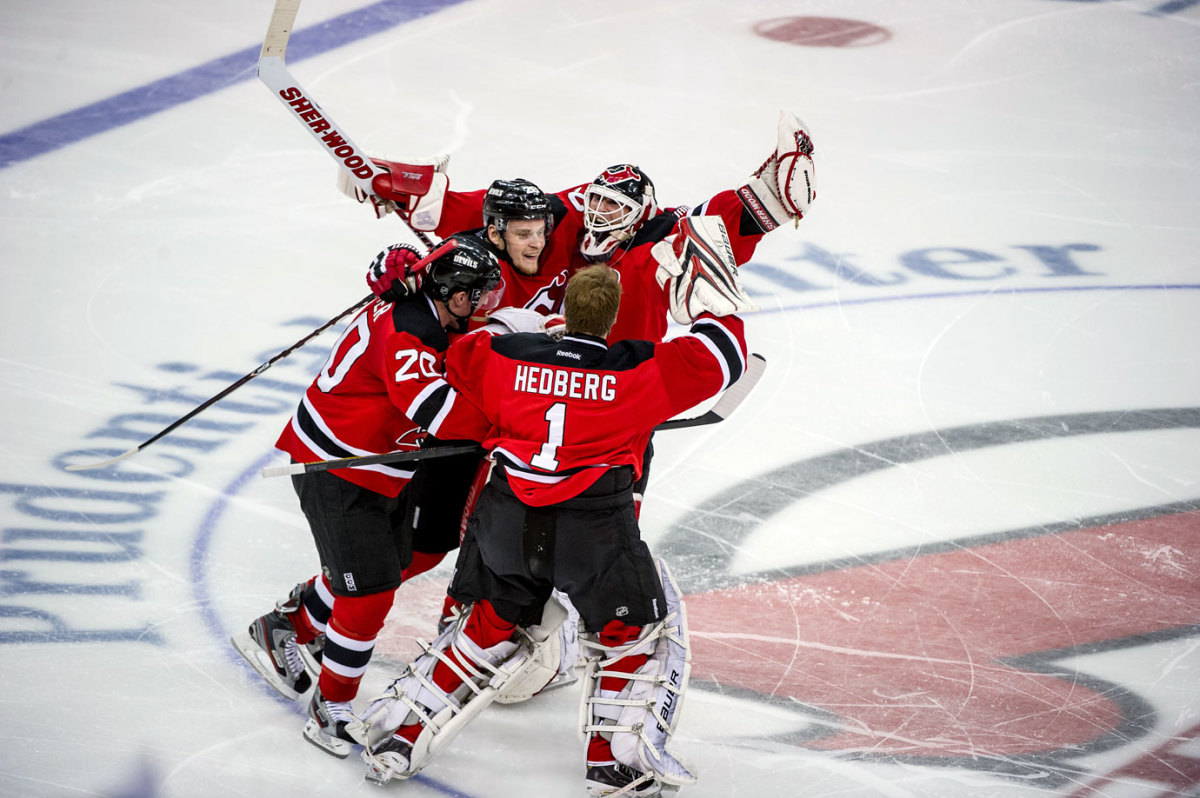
[650,216,758,324]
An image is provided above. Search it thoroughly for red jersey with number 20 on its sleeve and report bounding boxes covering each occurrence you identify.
[275,293,463,496]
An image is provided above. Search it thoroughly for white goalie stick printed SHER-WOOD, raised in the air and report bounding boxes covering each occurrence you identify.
[258,0,434,251]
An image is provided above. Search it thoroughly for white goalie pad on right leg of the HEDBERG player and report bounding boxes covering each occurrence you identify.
[580,558,696,787]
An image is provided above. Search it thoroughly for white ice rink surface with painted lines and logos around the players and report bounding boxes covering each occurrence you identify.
[0,0,1200,798]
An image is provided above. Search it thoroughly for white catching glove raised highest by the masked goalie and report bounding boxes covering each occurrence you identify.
[738,110,817,233]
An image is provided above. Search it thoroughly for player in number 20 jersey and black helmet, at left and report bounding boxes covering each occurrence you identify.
[233,235,500,757]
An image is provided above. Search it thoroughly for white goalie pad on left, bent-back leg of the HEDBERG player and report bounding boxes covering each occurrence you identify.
[349,598,568,785]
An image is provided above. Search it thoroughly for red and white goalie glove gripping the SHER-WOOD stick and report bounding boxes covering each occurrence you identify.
[337,155,450,233]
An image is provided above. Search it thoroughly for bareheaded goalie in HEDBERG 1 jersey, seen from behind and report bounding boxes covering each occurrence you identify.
[350,252,752,797]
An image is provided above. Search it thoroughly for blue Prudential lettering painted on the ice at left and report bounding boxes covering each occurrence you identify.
[0,319,326,646]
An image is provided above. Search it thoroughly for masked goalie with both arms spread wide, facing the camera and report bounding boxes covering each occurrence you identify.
[338,106,816,342]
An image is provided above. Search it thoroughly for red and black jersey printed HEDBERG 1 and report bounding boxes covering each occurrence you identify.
[436,314,746,506]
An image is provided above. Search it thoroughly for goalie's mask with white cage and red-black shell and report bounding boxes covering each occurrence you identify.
[580,163,659,263]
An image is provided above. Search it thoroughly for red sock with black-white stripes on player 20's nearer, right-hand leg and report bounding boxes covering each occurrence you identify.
[317,590,396,702]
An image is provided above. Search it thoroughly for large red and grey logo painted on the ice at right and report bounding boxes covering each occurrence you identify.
[660,408,1200,788]
